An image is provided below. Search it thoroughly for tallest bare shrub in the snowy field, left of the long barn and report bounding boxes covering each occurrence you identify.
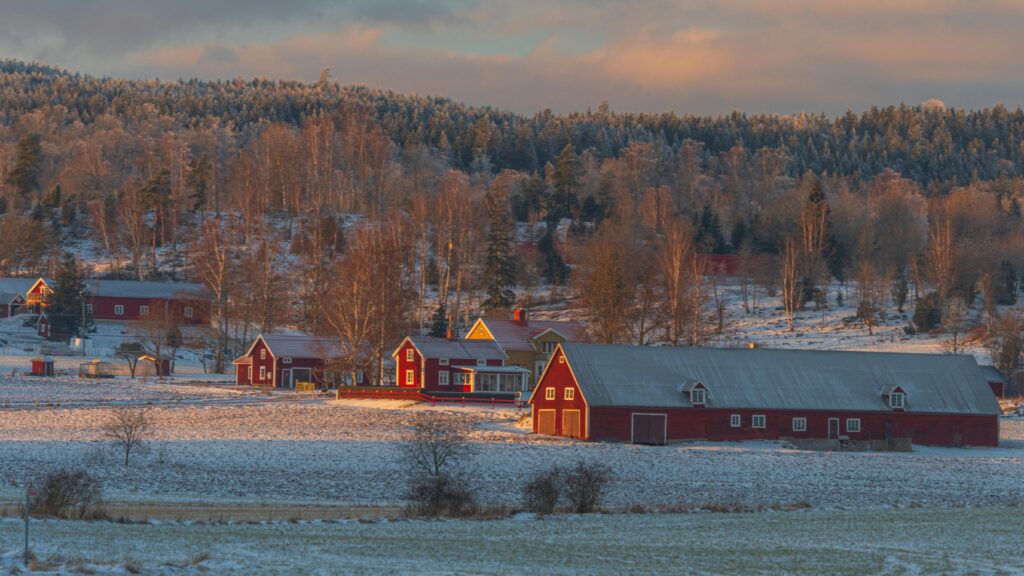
[402,414,474,517]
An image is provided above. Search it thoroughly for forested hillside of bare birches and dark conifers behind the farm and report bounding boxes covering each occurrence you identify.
[0,60,1024,375]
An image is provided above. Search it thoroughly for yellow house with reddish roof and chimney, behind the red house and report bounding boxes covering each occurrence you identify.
[466,310,591,389]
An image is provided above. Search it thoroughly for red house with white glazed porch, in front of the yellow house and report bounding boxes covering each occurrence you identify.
[391,336,529,394]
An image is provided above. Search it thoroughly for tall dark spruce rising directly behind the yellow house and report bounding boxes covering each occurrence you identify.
[483,191,517,311]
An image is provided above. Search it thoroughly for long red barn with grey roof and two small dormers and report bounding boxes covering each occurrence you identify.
[529,343,1000,446]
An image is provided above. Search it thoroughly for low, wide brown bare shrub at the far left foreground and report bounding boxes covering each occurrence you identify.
[30,469,103,520]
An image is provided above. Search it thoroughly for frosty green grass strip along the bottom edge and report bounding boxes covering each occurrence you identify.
[0,508,1024,575]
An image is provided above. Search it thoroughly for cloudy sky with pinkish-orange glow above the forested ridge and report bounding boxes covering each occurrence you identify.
[0,0,1024,115]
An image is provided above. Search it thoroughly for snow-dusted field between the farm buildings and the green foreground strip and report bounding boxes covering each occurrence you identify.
[0,379,1024,507]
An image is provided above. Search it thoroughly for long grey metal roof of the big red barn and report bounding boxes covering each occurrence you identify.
[562,343,1000,414]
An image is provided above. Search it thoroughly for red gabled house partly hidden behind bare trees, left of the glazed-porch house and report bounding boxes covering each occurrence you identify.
[234,334,367,388]
